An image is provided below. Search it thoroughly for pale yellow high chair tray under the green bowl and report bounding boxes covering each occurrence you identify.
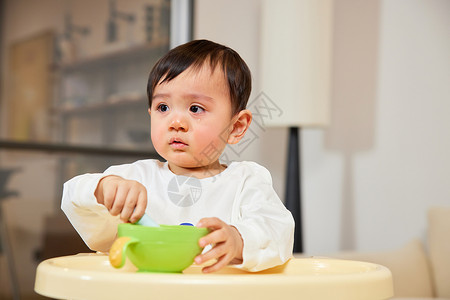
[35,254,393,300]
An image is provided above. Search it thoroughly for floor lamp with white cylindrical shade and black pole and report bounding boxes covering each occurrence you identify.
[260,0,333,253]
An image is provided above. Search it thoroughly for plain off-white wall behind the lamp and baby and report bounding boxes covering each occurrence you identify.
[195,0,450,254]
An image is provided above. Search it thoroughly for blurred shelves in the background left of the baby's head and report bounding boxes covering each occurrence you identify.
[53,38,169,150]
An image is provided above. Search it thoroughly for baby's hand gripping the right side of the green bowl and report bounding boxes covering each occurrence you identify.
[195,218,244,273]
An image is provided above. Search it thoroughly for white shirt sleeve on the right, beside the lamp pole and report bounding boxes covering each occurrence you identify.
[232,166,294,271]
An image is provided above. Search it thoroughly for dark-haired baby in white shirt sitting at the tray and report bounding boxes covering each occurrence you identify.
[62,40,294,272]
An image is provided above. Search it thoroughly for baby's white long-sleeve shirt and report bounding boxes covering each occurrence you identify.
[61,159,294,271]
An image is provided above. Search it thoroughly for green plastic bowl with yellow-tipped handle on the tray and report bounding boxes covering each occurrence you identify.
[109,223,208,273]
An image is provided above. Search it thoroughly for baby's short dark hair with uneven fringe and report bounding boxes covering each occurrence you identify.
[147,40,252,115]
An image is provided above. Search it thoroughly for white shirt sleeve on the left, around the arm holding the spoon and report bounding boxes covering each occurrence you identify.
[61,173,120,252]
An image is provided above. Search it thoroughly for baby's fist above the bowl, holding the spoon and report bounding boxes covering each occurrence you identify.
[94,175,147,223]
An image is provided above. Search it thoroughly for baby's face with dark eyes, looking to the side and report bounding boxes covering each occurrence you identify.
[149,64,233,173]
